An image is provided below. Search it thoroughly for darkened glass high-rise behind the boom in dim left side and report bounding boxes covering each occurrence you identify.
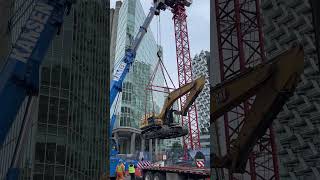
[0,0,109,180]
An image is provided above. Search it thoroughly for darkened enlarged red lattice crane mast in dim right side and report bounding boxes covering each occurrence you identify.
[213,0,279,180]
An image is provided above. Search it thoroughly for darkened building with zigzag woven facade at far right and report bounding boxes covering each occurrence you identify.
[261,0,320,180]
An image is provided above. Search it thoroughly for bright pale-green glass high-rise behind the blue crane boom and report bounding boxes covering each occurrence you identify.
[111,0,164,154]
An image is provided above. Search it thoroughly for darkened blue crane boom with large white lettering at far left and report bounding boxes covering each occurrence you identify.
[0,0,72,146]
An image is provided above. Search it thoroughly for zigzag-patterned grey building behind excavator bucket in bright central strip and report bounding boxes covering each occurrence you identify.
[192,51,210,135]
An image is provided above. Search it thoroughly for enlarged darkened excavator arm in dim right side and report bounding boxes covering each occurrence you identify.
[210,47,304,173]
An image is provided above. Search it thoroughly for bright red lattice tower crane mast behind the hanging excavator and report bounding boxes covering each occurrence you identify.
[171,0,200,158]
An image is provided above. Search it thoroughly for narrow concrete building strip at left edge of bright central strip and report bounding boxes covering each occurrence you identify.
[110,1,122,80]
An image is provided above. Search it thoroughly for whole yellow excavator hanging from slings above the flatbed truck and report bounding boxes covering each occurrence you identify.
[140,76,205,139]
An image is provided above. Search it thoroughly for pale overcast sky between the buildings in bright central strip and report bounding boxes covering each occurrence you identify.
[110,0,210,87]
